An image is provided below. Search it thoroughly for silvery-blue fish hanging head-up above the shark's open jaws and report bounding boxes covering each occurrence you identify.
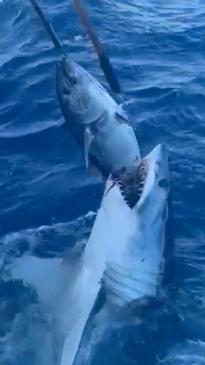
[56,57,140,177]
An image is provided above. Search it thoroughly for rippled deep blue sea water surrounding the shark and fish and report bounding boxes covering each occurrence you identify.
[0,0,205,365]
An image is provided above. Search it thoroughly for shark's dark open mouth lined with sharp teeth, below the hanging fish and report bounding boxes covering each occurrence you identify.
[113,159,148,209]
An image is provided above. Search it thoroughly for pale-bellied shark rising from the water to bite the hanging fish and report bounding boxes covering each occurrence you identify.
[60,145,170,365]
